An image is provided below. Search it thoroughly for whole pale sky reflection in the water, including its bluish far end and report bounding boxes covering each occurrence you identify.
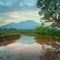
[0,35,56,60]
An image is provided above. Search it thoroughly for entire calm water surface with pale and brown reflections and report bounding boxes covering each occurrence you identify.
[0,35,60,60]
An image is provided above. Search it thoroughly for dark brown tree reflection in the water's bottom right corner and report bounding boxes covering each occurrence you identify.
[41,49,60,60]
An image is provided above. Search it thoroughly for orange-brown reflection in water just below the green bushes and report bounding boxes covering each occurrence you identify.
[35,36,60,49]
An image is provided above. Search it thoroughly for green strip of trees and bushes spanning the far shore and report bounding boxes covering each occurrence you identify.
[0,25,60,39]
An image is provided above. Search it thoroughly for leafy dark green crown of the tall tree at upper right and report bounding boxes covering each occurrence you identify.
[37,0,60,24]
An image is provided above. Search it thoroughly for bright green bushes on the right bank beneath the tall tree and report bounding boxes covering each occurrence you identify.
[34,26,60,39]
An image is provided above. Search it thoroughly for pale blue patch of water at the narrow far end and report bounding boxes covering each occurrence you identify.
[16,35,35,44]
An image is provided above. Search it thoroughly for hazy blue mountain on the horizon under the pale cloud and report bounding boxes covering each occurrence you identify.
[2,20,41,29]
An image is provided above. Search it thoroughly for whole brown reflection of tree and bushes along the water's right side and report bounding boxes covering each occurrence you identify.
[36,37,60,60]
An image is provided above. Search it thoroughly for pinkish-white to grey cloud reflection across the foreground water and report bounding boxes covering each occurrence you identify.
[0,44,41,60]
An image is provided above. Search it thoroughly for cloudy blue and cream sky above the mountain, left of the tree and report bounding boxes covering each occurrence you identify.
[0,0,40,25]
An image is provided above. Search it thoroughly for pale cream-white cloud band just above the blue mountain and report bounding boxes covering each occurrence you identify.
[0,10,40,25]
